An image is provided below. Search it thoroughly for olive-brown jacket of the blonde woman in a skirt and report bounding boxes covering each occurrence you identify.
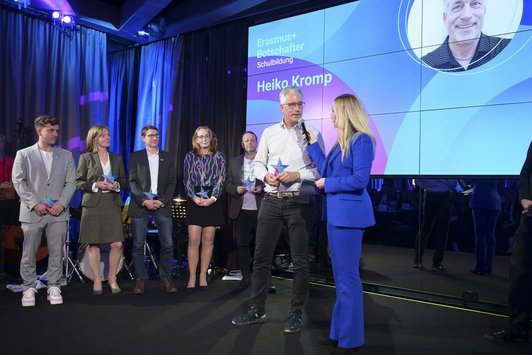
[76,153,127,207]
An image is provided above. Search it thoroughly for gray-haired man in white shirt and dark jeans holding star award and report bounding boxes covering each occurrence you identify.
[232,86,323,333]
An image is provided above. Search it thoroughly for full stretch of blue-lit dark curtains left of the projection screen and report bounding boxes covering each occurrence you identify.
[0,8,248,195]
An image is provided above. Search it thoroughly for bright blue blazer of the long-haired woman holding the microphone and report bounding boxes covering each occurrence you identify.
[307,134,375,228]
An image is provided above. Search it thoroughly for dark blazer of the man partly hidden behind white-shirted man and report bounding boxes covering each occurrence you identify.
[225,154,264,219]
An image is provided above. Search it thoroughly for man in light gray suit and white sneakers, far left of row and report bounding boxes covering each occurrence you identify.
[12,115,76,307]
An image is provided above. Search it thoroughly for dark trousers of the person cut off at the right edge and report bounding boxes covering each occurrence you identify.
[508,216,532,336]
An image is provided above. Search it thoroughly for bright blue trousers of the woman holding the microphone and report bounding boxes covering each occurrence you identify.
[327,224,364,348]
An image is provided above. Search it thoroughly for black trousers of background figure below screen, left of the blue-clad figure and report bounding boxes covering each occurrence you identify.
[414,191,451,266]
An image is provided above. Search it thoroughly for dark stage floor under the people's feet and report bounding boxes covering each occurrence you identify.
[0,276,532,355]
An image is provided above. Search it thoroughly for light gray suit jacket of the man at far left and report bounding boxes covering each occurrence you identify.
[12,144,76,223]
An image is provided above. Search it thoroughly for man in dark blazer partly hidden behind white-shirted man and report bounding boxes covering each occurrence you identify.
[225,131,264,289]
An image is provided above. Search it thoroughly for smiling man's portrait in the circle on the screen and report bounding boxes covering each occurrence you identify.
[421,0,510,72]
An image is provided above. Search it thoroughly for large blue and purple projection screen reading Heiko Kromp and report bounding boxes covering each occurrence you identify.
[247,0,532,176]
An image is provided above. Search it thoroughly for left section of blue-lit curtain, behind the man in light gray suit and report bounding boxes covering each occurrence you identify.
[0,8,109,160]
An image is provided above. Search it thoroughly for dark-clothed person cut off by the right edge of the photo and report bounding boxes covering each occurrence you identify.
[484,142,532,342]
